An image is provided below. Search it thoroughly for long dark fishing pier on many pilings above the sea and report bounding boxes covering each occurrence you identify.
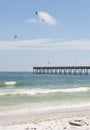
[33,66,90,75]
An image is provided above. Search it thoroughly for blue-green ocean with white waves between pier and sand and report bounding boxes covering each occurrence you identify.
[0,72,90,114]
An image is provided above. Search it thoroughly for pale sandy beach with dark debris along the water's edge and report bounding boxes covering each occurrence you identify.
[0,107,90,130]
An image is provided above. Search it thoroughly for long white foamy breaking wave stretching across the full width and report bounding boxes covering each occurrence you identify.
[0,87,90,96]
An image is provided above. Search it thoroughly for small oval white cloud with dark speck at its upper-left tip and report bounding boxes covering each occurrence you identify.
[35,11,56,25]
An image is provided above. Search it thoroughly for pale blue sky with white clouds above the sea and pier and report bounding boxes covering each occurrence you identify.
[0,0,90,71]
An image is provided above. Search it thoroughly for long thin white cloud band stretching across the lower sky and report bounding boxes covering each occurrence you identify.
[0,39,90,50]
